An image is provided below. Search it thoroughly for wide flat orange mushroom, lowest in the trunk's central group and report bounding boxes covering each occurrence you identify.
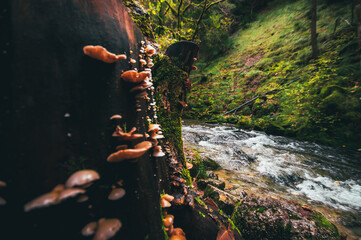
[107,141,152,162]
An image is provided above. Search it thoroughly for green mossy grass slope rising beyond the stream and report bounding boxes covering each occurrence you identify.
[186,0,361,148]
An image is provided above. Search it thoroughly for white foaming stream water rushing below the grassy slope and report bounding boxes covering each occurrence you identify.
[183,123,361,239]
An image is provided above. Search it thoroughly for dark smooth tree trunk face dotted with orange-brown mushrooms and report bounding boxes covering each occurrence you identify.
[0,0,165,240]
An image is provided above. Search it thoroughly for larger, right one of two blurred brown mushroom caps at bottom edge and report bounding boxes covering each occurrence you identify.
[93,218,122,240]
